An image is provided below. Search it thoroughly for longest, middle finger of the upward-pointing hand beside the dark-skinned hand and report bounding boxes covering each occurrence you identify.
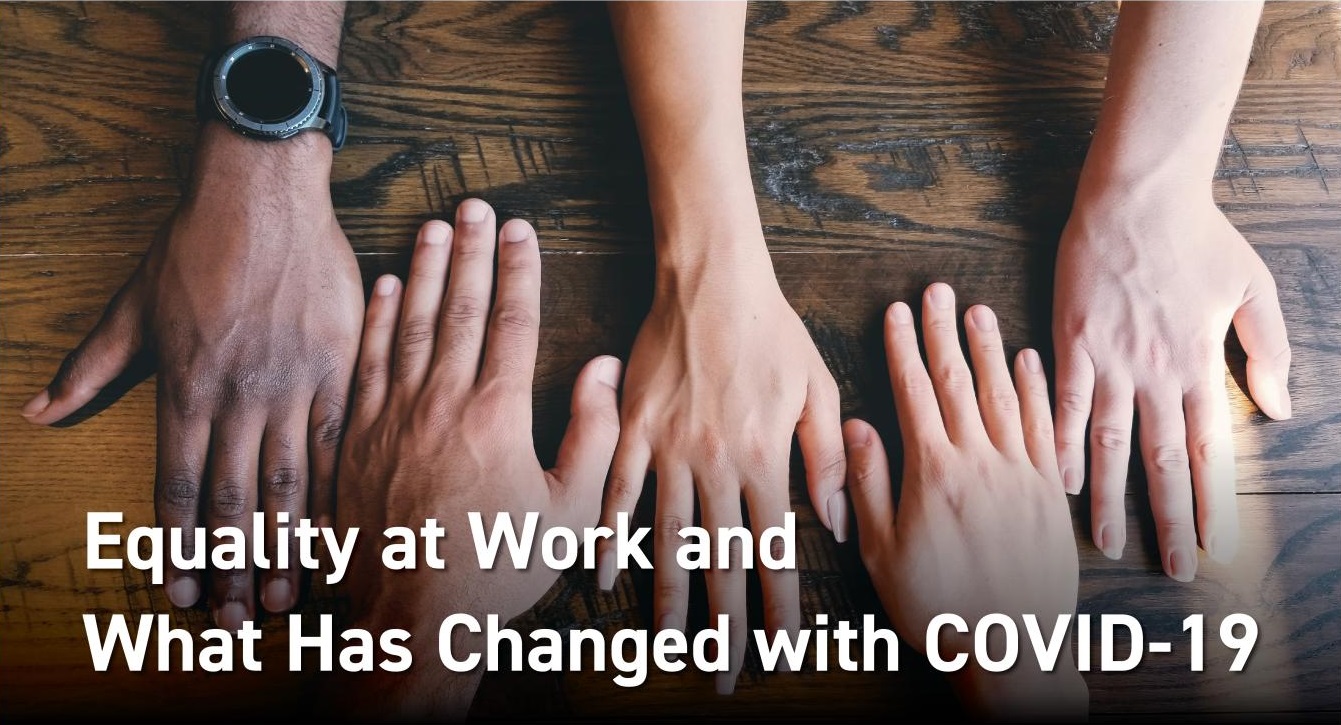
[433,198,495,391]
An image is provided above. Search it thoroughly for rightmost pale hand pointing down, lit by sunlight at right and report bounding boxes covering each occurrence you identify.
[1053,186,1290,582]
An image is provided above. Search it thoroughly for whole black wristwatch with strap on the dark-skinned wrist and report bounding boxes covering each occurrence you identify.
[196,35,349,151]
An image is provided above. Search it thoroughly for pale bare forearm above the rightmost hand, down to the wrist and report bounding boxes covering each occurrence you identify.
[1081,1,1262,192]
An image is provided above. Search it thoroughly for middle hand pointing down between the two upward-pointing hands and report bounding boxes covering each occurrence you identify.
[599,239,848,694]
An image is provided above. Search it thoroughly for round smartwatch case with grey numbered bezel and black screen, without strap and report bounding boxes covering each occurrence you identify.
[212,36,326,138]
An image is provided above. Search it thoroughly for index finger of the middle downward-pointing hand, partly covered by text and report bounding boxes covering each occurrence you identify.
[744,463,793,651]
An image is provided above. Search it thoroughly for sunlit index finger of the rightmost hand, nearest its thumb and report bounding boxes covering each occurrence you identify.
[1183,380,1239,562]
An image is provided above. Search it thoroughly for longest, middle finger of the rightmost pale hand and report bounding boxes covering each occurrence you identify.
[1139,387,1196,582]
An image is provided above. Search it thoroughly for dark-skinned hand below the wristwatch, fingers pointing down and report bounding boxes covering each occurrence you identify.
[23,123,363,629]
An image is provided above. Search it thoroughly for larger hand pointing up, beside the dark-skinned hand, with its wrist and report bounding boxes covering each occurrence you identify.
[337,200,620,720]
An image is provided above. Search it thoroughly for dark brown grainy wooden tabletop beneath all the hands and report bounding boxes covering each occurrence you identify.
[0,3,1341,722]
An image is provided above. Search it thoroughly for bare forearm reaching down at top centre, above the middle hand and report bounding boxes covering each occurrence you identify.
[610,3,767,280]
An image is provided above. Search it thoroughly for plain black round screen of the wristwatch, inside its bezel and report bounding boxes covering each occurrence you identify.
[224,48,312,123]
